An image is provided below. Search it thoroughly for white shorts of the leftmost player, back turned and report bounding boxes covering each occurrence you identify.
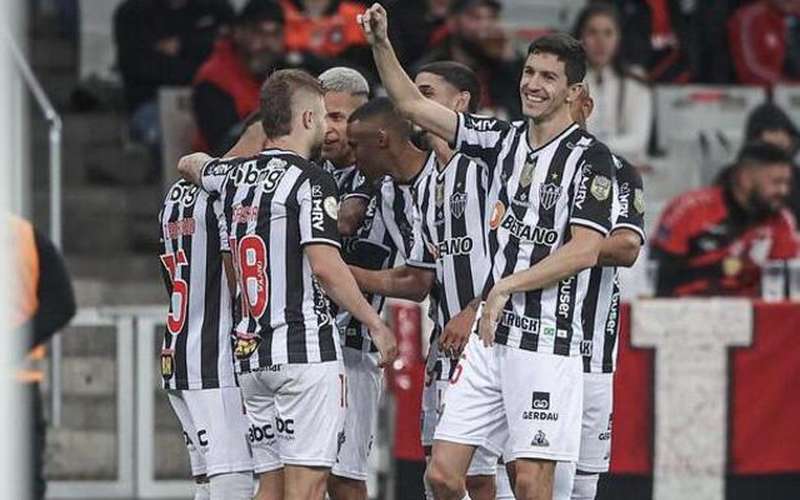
[167,387,253,476]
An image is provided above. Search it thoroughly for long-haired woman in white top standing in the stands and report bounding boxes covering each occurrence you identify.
[575,3,653,164]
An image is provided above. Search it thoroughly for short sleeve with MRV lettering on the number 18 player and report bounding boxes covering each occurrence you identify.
[297,170,341,248]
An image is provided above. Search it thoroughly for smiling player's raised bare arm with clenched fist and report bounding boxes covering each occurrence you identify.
[360,3,458,143]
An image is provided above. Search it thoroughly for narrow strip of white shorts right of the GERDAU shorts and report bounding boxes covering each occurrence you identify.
[578,373,614,474]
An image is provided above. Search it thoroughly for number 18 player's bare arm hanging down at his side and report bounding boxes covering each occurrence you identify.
[305,245,397,366]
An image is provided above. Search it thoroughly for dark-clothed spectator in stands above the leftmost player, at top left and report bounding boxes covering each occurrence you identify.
[114,0,233,170]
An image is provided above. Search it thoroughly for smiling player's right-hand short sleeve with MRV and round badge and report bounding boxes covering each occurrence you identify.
[570,142,616,236]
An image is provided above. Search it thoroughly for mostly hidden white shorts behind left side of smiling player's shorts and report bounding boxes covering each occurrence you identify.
[422,340,499,476]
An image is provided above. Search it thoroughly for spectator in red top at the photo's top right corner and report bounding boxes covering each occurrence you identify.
[728,0,800,85]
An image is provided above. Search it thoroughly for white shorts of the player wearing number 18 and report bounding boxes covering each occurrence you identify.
[239,360,344,474]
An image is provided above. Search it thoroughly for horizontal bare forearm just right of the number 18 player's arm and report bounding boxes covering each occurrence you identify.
[350,266,436,302]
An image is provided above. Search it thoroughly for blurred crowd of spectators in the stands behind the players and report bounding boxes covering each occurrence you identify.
[106,0,800,295]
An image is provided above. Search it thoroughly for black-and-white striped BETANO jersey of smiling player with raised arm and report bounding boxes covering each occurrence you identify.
[456,114,614,356]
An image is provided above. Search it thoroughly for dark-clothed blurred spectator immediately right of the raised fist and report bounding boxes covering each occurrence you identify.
[386,0,451,66]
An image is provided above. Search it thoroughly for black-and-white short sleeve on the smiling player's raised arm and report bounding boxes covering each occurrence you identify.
[453,113,514,165]
